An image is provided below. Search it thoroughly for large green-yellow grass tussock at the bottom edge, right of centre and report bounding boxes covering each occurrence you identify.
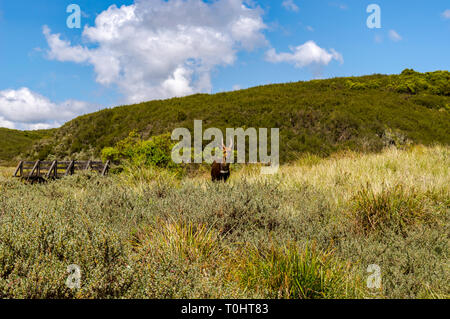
[239,244,360,299]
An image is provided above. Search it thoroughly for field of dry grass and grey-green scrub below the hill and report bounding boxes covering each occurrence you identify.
[0,146,450,298]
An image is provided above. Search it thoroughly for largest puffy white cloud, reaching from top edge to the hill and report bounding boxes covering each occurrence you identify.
[43,0,267,102]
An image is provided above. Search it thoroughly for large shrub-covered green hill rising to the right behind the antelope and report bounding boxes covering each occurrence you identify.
[11,70,450,162]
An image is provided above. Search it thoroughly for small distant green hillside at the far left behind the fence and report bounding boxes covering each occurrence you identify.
[0,128,53,165]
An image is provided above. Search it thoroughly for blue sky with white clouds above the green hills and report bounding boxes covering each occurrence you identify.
[0,0,450,129]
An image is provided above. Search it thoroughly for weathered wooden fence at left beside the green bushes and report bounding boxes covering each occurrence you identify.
[13,161,110,181]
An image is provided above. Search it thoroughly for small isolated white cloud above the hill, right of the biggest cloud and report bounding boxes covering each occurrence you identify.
[266,41,344,68]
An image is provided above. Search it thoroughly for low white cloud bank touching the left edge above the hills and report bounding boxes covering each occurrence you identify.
[0,88,92,130]
